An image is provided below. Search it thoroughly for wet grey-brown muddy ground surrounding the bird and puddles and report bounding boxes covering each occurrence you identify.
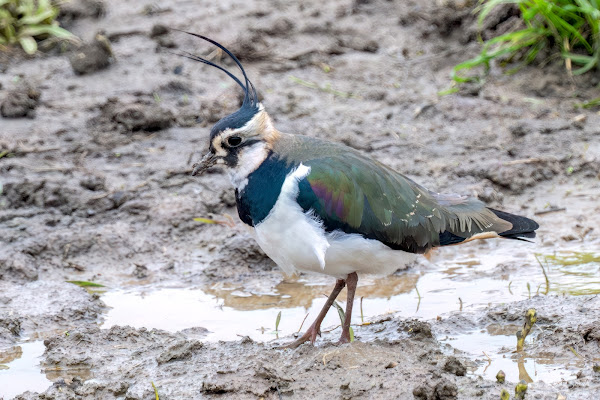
[0,0,600,400]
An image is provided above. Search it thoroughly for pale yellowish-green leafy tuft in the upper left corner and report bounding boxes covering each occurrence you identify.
[0,0,76,54]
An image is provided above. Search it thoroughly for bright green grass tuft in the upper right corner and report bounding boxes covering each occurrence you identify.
[452,0,600,83]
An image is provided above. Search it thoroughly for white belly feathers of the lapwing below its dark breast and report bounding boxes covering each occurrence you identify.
[255,164,416,279]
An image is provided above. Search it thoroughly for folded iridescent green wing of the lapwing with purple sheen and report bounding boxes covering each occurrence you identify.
[298,151,511,253]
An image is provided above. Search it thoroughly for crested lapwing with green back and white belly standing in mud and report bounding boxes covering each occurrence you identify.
[184,33,538,348]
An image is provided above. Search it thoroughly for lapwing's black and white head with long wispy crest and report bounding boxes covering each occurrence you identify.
[185,32,279,180]
